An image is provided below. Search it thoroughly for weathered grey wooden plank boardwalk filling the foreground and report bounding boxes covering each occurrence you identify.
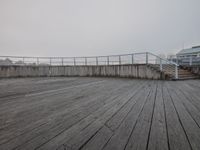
[0,78,200,150]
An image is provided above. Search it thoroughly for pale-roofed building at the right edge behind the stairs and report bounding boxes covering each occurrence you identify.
[176,46,200,59]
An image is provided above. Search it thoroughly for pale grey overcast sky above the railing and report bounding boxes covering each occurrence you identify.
[0,0,200,56]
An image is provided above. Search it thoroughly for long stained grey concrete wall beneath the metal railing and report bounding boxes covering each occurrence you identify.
[0,65,164,79]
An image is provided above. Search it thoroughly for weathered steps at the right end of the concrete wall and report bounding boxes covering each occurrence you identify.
[149,64,199,80]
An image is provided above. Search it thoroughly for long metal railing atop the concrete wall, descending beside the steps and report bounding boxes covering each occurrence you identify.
[0,52,178,78]
